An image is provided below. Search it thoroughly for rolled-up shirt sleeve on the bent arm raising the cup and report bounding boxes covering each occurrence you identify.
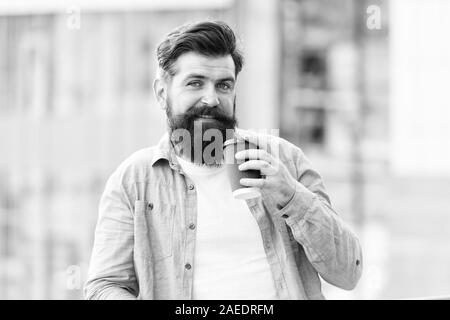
[276,148,363,290]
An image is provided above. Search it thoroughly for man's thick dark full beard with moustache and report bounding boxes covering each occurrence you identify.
[166,100,237,166]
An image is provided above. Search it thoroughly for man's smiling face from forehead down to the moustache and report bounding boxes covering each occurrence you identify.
[165,52,237,164]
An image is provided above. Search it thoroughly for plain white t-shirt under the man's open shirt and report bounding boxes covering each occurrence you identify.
[178,157,278,300]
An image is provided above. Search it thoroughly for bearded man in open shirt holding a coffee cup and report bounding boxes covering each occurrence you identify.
[85,22,362,300]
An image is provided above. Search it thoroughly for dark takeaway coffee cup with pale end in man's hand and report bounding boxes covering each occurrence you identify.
[223,137,261,200]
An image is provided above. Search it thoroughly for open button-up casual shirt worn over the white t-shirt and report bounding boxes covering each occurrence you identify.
[85,129,363,300]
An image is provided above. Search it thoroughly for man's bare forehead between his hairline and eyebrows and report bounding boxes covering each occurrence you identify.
[174,52,235,79]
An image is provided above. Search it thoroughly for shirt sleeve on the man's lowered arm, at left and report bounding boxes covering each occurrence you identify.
[84,172,138,299]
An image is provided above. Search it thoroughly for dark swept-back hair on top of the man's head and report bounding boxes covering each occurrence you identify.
[156,21,244,76]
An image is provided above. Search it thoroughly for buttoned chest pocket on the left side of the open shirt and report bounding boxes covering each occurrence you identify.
[134,200,176,261]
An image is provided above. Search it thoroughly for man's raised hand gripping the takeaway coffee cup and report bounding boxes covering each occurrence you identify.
[235,149,297,208]
